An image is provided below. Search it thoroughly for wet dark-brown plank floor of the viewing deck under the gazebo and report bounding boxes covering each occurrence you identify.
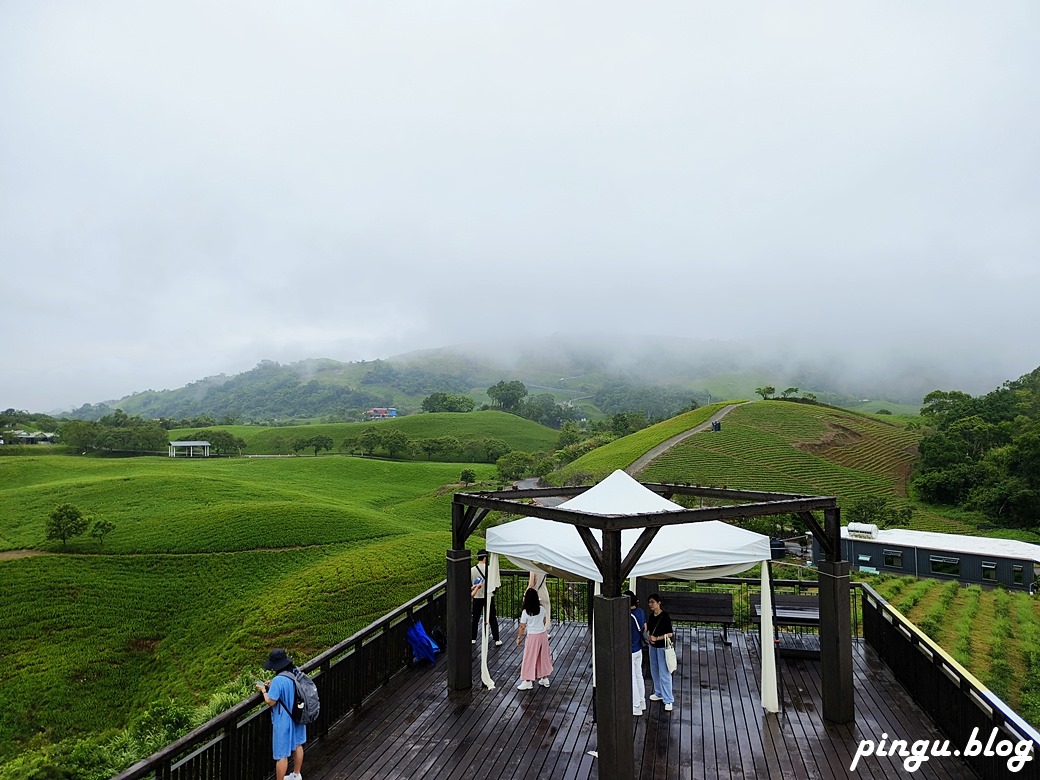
[304,620,976,780]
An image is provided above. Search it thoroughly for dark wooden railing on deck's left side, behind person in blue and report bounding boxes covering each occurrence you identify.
[113,572,449,780]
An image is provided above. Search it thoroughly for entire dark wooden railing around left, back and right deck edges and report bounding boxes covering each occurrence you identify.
[113,571,1040,780]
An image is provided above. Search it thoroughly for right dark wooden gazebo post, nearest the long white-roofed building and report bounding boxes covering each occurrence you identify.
[820,508,856,723]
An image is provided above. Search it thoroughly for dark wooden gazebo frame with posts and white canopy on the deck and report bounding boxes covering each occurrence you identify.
[447,472,855,780]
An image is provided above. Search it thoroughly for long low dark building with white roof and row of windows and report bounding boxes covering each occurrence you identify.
[813,523,1040,593]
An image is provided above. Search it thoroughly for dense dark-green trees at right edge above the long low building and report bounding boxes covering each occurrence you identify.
[912,368,1040,527]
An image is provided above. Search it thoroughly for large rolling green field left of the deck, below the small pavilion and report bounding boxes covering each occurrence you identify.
[0,457,493,759]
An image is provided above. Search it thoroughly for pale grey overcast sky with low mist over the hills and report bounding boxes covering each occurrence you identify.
[0,0,1040,411]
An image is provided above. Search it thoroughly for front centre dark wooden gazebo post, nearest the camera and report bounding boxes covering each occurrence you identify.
[593,530,635,780]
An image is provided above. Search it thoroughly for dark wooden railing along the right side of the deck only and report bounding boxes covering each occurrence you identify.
[862,584,1040,780]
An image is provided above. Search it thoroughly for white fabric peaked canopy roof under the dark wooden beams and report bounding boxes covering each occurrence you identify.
[486,471,770,581]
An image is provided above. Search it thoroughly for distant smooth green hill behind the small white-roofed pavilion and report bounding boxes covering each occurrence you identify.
[170,411,560,454]
